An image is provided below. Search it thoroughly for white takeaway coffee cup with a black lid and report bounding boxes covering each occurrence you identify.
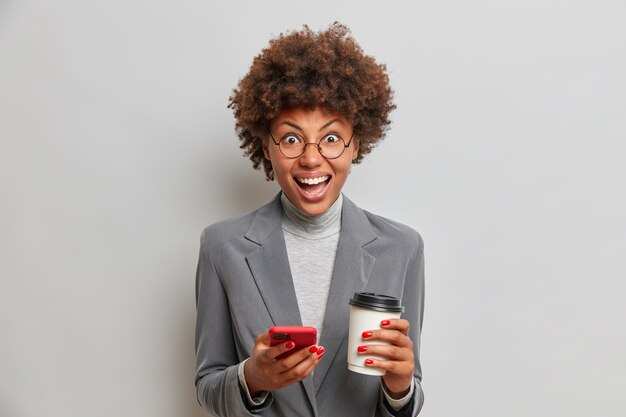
[348,292,404,376]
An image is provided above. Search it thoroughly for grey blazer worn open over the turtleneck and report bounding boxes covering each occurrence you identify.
[195,194,424,417]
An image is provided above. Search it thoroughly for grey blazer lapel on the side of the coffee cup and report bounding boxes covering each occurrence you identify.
[313,196,376,392]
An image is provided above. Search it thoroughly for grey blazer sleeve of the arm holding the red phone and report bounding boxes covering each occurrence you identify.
[195,230,273,417]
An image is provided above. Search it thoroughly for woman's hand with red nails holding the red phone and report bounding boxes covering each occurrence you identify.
[243,332,324,396]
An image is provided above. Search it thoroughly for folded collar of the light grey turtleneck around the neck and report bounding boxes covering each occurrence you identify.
[280,193,343,239]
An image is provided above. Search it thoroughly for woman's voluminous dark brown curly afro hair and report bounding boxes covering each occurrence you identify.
[228,22,396,181]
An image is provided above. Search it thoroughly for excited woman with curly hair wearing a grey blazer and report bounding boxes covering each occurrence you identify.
[196,23,424,417]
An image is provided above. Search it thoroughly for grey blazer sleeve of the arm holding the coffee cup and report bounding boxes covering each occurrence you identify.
[378,232,425,417]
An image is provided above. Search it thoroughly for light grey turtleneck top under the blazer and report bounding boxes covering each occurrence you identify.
[280,193,343,341]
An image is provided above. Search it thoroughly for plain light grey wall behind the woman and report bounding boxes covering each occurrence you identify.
[0,0,626,417]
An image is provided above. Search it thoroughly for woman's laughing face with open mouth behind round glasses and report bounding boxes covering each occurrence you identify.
[263,107,358,215]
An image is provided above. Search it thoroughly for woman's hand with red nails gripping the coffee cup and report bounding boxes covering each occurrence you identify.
[359,319,415,399]
